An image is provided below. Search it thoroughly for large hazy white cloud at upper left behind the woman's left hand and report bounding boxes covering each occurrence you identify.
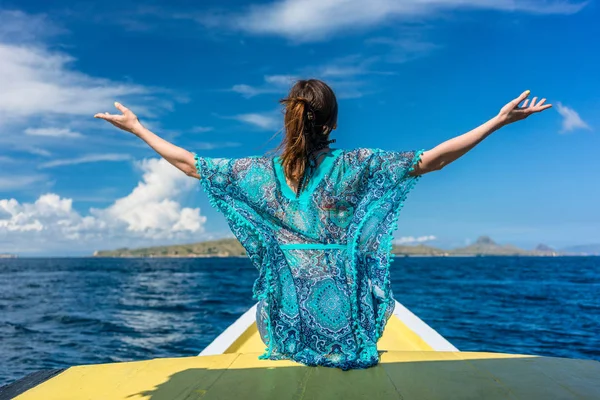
[0,11,175,156]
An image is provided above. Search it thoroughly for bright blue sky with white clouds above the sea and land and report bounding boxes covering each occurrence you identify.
[0,0,600,256]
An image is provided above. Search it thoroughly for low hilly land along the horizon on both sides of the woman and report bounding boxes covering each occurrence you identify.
[94,236,580,257]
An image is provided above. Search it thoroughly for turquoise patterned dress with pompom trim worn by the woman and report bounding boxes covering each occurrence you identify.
[195,148,421,370]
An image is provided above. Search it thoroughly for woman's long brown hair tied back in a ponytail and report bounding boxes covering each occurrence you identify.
[278,79,338,194]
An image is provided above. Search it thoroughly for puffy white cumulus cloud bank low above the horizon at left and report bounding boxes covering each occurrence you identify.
[0,159,206,252]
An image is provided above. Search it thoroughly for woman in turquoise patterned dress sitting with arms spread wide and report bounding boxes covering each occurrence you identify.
[95,79,551,369]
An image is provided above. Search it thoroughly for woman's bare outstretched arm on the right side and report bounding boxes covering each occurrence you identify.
[411,90,552,175]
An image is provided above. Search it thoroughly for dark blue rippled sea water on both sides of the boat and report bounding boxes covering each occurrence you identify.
[0,257,600,385]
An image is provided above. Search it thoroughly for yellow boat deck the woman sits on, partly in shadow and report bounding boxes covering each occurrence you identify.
[9,310,600,400]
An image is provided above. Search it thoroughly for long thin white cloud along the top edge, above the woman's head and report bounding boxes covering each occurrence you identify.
[233,0,587,41]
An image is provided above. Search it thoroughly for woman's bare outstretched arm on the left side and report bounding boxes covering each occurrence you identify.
[94,102,200,178]
